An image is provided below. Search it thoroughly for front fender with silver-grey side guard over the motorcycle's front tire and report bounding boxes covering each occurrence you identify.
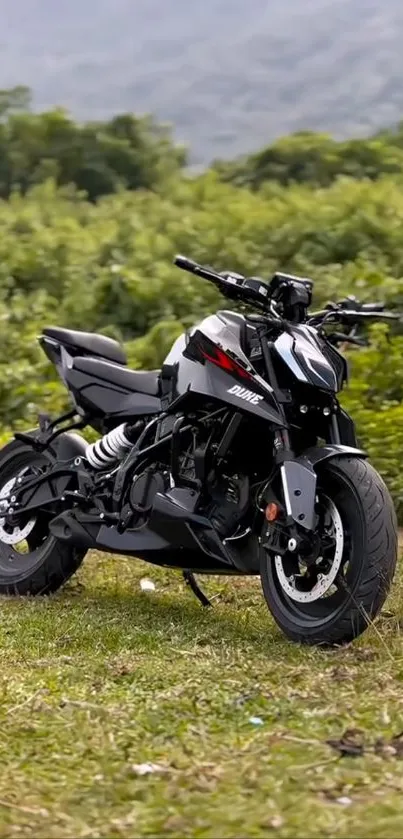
[281,444,368,530]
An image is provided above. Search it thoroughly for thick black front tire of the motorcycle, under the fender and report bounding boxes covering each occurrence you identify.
[261,457,397,646]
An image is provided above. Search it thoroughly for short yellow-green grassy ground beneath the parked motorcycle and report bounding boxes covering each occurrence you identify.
[0,556,403,839]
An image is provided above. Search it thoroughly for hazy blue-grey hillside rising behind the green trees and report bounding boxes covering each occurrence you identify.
[0,0,403,163]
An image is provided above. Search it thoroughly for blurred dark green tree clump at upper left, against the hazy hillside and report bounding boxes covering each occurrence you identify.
[0,87,185,200]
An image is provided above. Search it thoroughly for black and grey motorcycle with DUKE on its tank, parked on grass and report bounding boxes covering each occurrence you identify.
[0,256,397,644]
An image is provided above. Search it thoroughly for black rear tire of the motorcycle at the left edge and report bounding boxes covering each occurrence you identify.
[0,440,85,595]
